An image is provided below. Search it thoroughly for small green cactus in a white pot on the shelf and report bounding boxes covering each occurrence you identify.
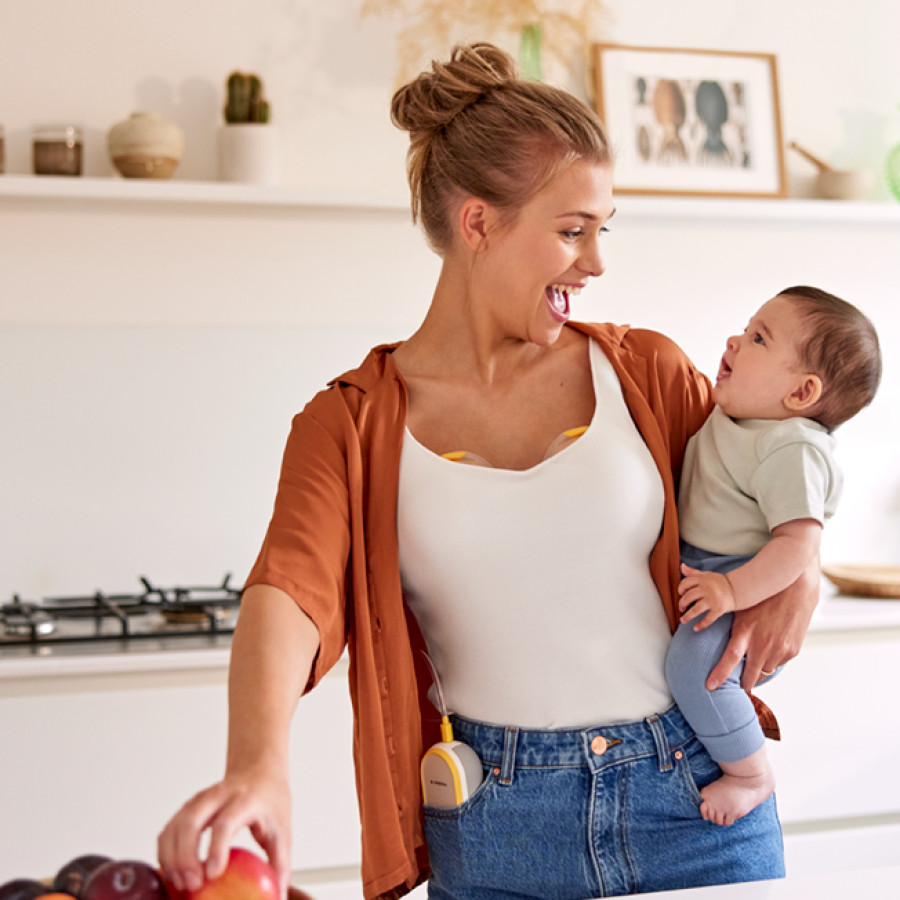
[219,71,278,184]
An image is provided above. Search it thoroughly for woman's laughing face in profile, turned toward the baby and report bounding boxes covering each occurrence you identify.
[478,161,615,346]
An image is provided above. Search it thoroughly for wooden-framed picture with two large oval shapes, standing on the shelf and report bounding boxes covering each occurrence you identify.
[594,44,787,197]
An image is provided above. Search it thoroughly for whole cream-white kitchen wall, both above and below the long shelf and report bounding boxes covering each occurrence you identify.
[0,0,900,598]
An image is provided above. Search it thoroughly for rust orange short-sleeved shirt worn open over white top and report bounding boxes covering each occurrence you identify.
[246,323,711,900]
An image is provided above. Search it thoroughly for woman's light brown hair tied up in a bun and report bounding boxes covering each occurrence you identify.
[391,43,612,254]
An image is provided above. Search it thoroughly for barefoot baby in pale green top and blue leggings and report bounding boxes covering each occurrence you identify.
[666,287,881,825]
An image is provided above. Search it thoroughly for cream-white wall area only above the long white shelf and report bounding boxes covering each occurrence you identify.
[0,0,900,196]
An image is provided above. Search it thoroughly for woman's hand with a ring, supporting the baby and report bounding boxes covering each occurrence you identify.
[706,556,819,691]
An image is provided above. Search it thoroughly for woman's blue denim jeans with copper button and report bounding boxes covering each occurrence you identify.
[425,707,784,900]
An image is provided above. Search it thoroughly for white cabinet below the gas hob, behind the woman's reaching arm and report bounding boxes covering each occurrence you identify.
[0,650,359,882]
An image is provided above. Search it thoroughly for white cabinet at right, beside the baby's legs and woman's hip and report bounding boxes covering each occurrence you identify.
[759,597,900,875]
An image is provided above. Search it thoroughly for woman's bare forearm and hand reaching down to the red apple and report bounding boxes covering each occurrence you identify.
[158,584,319,892]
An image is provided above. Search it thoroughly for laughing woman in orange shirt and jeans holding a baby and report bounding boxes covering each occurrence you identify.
[159,44,816,900]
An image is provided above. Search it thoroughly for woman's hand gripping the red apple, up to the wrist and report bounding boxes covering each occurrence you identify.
[158,771,291,895]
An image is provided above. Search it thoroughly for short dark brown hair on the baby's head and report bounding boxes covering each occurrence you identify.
[780,285,881,431]
